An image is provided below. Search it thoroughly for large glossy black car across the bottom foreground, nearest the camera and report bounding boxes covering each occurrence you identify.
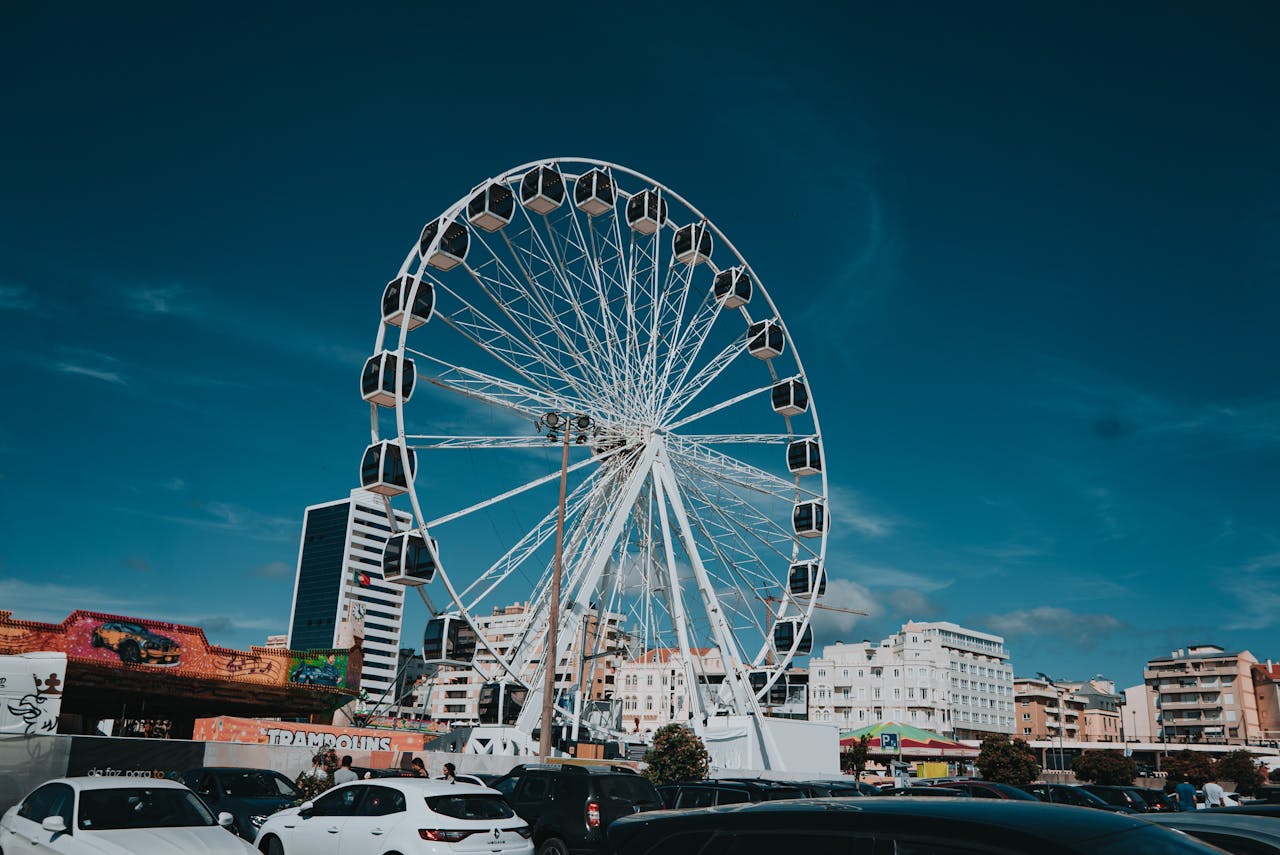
[608,799,1219,855]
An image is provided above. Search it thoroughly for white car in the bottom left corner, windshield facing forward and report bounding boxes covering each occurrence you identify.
[0,777,253,855]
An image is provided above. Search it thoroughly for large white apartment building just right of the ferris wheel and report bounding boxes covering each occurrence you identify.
[809,621,1015,739]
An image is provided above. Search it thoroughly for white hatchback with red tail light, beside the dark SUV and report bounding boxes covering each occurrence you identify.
[255,778,534,855]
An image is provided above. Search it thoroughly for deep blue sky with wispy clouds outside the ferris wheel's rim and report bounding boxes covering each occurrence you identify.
[0,3,1280,685]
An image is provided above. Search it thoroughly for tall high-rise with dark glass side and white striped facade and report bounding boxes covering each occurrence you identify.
[288,490,411,704]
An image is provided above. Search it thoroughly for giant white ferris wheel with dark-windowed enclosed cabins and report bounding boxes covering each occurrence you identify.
[361,157,829,762]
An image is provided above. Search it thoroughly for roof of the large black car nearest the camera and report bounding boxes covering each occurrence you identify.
[609,797,1162,849]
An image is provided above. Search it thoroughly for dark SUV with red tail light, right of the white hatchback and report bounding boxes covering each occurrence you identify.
[489,764,662,855]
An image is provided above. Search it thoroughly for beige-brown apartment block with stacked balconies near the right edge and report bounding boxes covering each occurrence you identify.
[1143,644,1261,744]
